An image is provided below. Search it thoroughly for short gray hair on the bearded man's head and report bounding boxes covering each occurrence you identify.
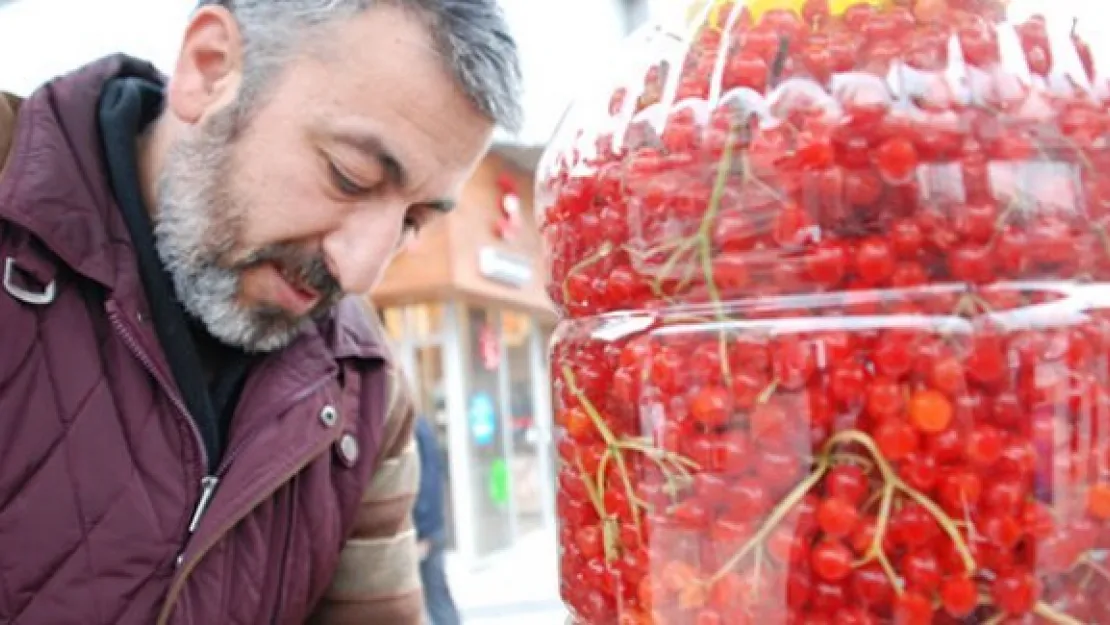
[199,0,524,132]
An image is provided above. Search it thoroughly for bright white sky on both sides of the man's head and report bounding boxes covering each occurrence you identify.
[0,0,643,144]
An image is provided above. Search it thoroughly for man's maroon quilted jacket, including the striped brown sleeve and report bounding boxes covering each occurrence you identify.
[0,57,421,625]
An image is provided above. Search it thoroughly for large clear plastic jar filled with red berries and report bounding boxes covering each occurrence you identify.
[536,0,1110,625]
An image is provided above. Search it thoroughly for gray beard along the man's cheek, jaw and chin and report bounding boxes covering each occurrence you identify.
[154,107,306,352]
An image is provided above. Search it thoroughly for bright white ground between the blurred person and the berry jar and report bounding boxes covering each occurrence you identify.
[446,531,566,625]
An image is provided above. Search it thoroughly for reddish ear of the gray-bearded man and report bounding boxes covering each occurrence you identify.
[167,6,243,124]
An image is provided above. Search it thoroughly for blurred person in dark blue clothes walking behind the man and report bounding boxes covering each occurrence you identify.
[413,416,462,625]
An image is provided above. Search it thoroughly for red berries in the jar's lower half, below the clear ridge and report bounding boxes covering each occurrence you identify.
[554,295,1110,625]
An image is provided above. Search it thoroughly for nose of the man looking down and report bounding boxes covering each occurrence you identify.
[323,208,404,294]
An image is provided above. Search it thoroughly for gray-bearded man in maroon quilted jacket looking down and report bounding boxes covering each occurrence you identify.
[0,0,521,625]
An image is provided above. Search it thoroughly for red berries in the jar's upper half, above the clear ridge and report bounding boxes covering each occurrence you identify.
[542,0,1110,316]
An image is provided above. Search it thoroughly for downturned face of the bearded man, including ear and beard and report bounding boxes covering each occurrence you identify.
[155,7,493,351]
